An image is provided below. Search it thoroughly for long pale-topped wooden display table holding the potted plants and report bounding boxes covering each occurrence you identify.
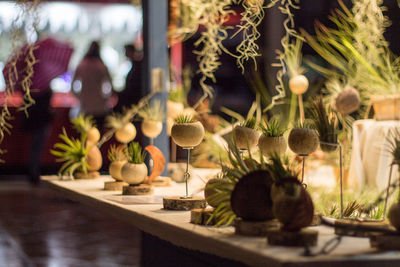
[42,173,400,267]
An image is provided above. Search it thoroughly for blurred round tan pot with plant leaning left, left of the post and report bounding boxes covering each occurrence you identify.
[106,112,136,144]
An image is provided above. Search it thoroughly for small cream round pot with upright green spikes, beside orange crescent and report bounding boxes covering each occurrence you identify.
[121,142,147,185]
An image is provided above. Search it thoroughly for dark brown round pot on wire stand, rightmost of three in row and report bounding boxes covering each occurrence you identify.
[288,128,319,155]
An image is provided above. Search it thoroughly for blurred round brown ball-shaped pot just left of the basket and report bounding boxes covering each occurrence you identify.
[335,86,361,114]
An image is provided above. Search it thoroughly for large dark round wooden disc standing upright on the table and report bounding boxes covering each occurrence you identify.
[231,171,274,221]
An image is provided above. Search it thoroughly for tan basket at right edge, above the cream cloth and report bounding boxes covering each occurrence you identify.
[371,95,400,121]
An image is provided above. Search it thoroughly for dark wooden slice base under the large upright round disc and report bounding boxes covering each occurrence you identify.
[234,218,280,236]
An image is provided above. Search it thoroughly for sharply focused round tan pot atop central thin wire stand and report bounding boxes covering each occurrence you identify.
[171,121,204,148]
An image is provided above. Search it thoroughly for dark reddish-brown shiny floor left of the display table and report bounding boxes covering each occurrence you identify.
[0,179,140,267]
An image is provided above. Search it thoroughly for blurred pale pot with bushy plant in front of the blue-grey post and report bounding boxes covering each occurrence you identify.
[138,101,165,138]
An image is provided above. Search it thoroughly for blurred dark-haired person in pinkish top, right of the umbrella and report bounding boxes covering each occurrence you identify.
[72,41,113,128]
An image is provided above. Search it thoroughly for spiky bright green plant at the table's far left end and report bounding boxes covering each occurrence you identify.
[50,128,91,177]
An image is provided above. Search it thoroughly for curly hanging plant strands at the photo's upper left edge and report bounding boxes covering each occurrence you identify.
[0,0,41,160]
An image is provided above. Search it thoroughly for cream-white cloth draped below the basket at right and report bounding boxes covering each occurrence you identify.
[349,120,400,191]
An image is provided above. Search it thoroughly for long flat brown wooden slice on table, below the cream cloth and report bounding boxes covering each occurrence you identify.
[335,219,391,237]
